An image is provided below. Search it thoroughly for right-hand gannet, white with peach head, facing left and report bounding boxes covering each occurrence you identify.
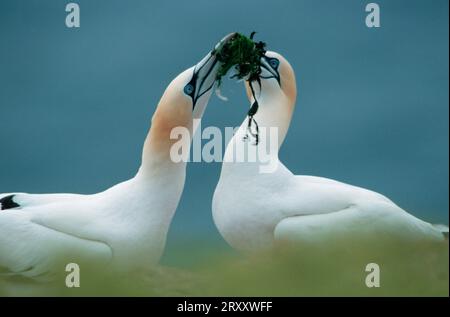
[212,52,448,253]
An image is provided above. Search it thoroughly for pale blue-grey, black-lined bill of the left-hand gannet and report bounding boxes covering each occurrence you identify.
[184,33,236,118]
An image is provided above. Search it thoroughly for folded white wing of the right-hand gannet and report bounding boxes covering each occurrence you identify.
[274,201,444,247]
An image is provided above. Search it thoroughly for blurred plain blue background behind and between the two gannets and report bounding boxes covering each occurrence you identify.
[0,0,449,262]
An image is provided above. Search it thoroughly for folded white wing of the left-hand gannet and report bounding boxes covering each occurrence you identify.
[0,205,112,279]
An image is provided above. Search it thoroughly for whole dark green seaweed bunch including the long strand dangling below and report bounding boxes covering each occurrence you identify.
[216,32,266,145]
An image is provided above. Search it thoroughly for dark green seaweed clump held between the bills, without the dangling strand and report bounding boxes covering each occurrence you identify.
[216,32,266,86]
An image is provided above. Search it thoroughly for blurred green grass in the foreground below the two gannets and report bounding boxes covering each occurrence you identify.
[0,239,449,296]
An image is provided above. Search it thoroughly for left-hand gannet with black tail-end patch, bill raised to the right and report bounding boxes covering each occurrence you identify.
[0,34,237,281]
